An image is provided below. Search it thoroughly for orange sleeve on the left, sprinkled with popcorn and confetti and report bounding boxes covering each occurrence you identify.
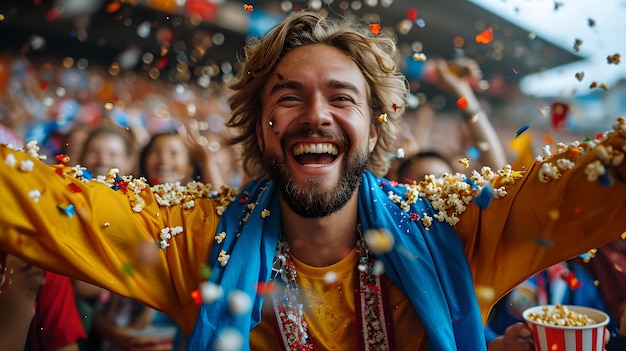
[0,146,232,332]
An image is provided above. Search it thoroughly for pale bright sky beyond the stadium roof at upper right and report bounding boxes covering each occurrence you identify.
[468,0,626,97]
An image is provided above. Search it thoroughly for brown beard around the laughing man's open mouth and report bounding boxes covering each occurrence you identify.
[263,133,370,218]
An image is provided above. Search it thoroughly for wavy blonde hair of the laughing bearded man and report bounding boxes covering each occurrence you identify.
[227,11,409,179]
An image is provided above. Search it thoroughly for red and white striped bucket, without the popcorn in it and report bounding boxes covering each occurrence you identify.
[523,305,609,351]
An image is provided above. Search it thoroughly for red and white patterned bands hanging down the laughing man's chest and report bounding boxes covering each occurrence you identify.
[272,225,394,351]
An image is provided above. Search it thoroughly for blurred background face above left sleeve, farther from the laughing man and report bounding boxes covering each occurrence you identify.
[80,133,133,175]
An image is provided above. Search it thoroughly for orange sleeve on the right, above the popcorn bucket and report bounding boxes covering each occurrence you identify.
[456,118,626,324]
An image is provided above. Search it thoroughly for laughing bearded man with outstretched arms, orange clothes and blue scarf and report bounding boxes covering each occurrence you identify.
[0,12,626,350]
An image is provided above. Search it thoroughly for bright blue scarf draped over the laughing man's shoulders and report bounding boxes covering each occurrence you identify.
[188,172,486,351]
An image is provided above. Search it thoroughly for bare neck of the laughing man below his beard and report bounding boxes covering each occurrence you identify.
[281,192,358,267]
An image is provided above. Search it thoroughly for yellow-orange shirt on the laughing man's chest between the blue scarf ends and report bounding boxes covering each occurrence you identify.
[250,251,428,351]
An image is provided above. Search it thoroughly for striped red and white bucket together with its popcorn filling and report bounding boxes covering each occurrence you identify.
[523,305,609,351]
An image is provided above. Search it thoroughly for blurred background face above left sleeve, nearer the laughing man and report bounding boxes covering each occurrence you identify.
[143,134,194,184]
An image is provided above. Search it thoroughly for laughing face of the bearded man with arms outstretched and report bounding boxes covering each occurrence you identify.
[257,44,378,217]
